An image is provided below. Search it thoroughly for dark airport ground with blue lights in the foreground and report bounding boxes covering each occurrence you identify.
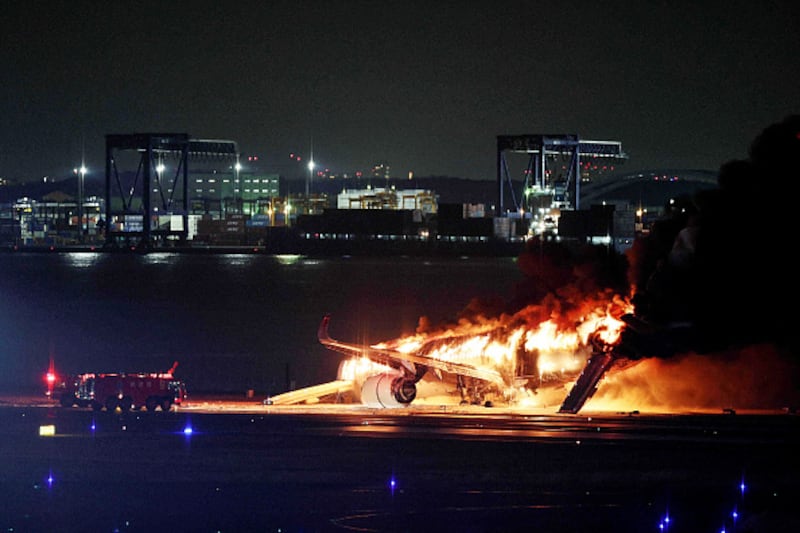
[0,397,800,533]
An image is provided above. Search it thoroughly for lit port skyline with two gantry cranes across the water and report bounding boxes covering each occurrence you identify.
[0,133,716,253]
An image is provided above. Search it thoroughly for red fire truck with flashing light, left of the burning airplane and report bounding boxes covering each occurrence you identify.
[53,361,186,411]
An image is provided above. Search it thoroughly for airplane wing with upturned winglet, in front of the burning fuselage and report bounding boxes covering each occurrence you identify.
[317,315,505,386]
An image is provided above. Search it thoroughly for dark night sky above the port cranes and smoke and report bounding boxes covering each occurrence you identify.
[0,0,800,181]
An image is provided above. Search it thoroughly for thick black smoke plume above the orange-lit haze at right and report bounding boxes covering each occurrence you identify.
[628,115,800,352]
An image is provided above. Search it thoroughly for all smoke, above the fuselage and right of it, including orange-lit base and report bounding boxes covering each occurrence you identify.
[400,115,800,410]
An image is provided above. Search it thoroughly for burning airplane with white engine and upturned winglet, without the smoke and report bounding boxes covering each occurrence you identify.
[318,278,631,413]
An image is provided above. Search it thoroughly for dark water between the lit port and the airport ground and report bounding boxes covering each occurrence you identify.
[0,252,521,395]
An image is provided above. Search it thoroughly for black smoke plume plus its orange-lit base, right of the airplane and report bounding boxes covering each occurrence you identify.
[592,115,800,409]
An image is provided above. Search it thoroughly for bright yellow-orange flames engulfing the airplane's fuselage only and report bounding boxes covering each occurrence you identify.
[340,293,633,400]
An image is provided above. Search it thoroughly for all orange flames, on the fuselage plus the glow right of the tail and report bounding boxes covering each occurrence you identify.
[332,297,800,412]
